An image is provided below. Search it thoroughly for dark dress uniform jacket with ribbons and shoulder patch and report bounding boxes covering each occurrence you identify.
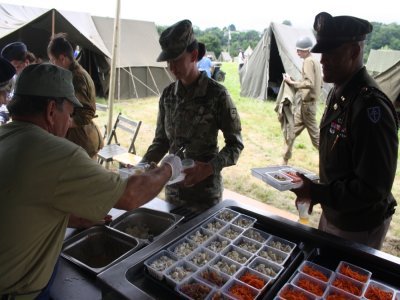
[311,68,398,231]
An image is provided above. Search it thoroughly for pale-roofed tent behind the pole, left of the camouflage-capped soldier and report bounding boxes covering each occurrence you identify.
[93,16,172,99]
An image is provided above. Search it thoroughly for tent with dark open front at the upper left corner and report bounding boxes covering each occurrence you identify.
[0,4,111,96]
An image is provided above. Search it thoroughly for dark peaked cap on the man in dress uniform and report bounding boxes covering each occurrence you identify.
[311,12,372,53]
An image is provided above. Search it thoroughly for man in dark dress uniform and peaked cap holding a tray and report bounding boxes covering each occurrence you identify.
[292,12,398,249]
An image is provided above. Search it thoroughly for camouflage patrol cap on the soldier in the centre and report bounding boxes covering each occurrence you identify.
[157,20,195,61]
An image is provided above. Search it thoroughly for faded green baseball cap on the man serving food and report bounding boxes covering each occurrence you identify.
[14,63,82,107]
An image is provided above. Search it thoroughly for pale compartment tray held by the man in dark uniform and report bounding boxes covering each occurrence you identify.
[251,165,319,191]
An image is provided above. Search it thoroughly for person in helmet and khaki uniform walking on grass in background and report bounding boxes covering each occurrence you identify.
[283,37,322,165]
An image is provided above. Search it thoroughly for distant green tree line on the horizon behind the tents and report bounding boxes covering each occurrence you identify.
[157,20,400,61]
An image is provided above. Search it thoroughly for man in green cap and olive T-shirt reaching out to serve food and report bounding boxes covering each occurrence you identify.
[0,64,182,299]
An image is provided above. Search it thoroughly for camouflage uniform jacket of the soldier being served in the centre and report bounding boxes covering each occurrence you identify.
[143,72,243,209]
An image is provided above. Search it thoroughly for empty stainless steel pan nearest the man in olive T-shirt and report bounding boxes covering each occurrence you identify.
[61,226,144,274]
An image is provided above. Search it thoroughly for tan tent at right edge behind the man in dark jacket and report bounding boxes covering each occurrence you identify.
[366,49,400,106]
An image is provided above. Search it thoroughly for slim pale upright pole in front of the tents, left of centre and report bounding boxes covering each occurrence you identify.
[106,0,121,169]
